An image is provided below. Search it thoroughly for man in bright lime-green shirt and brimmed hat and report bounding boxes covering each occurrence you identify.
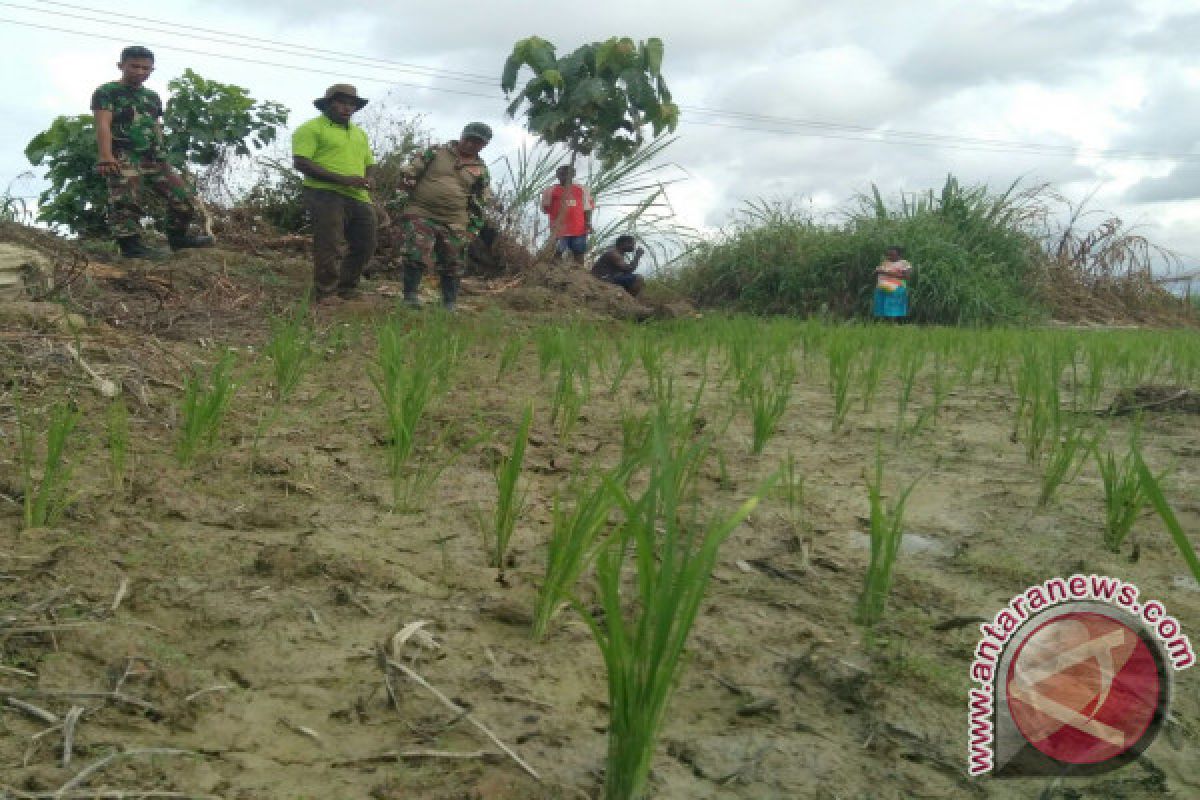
[292,84,376,302]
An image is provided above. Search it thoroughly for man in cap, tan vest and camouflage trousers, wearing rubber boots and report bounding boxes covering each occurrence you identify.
[388,122,492,311]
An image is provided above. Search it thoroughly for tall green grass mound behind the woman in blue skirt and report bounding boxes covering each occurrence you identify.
[674,176,1050,325]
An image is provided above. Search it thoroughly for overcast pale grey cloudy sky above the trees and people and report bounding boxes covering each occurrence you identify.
[0,0,1200,269]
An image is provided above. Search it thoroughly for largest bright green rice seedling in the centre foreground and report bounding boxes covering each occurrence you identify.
[571,409,761,800]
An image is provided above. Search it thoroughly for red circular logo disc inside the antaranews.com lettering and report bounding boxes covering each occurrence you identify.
[1008,612,1163,764]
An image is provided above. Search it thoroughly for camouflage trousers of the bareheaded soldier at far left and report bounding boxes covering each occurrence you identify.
[107,155,196,239]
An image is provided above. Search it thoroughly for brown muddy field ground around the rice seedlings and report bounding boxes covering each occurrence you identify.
[0,247,1200,800]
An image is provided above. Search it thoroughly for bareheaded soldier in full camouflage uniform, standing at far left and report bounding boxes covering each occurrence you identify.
[91,47,212,258]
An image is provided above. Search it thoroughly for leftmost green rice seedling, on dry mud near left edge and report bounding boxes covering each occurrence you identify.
[16,401,80,529]
